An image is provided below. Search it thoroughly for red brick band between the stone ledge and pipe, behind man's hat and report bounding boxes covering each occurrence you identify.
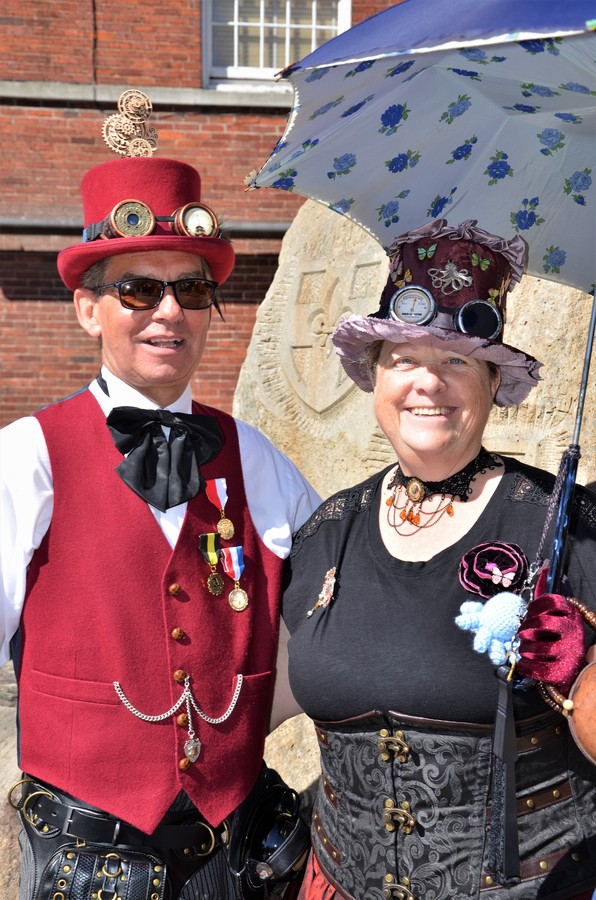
[0,104,301,227]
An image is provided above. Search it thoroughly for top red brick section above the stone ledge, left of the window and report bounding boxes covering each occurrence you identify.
[0,0,201,88]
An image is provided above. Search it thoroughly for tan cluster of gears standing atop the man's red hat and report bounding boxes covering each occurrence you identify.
[102,90,157,156]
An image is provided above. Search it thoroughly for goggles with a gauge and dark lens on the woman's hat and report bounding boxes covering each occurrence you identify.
[386,284,503,340]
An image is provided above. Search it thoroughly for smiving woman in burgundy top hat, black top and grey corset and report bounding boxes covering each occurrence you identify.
[283,220,596,900]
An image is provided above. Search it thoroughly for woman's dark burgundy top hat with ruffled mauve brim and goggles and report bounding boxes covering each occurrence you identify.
[332,219,542,406]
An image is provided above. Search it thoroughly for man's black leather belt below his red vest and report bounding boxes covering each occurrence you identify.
[21,782,227,856]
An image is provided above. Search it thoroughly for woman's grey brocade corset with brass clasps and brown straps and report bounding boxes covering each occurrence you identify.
[312,713,596,900]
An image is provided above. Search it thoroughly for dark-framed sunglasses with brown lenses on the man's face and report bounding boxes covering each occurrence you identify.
[94,278,219,309]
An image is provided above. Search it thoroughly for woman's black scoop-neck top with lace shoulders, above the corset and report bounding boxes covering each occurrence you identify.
[283,459,596,723]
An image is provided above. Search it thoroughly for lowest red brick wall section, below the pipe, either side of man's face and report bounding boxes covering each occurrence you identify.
[0,253,277,427]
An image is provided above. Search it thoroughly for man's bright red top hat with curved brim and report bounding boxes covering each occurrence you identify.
[58,157,234,290]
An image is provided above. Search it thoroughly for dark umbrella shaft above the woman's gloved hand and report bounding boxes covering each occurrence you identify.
[546,289,596,593]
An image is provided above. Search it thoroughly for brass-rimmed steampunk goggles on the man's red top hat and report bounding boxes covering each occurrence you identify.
[83,200,220,242]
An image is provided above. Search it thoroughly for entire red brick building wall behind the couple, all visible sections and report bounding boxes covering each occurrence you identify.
[0,0,391,425]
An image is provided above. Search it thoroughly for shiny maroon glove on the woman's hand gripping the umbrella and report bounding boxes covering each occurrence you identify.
[516,570,586,696]
